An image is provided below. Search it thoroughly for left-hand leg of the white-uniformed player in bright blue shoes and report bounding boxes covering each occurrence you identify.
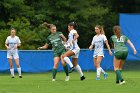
[95,56,103,80]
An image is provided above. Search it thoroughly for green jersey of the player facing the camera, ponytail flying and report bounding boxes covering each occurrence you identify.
[46,32,65,53]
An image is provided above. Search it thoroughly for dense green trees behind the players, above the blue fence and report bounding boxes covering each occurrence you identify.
[0,0,138,49]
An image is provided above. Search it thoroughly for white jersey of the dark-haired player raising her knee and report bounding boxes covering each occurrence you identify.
[68,29,80,50]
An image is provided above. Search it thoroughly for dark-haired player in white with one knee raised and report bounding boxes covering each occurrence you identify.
[62,22,85,80]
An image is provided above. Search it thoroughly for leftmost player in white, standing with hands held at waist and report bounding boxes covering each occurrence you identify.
[5,28,22,78]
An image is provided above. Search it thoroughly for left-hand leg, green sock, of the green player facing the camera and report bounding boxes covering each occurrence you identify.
[52,57,60,81]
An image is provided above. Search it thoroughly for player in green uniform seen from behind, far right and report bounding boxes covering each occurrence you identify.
[110,26,137,84]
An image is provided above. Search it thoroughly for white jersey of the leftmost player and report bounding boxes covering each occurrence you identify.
[5,36,21,51]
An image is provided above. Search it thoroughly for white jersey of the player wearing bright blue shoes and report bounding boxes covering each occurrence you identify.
[91,34,107,57]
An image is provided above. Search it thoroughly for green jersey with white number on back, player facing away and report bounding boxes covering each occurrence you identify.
[110,35,128,53]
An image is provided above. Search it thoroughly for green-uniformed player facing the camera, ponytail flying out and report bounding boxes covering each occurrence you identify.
[38,22,69,81]
